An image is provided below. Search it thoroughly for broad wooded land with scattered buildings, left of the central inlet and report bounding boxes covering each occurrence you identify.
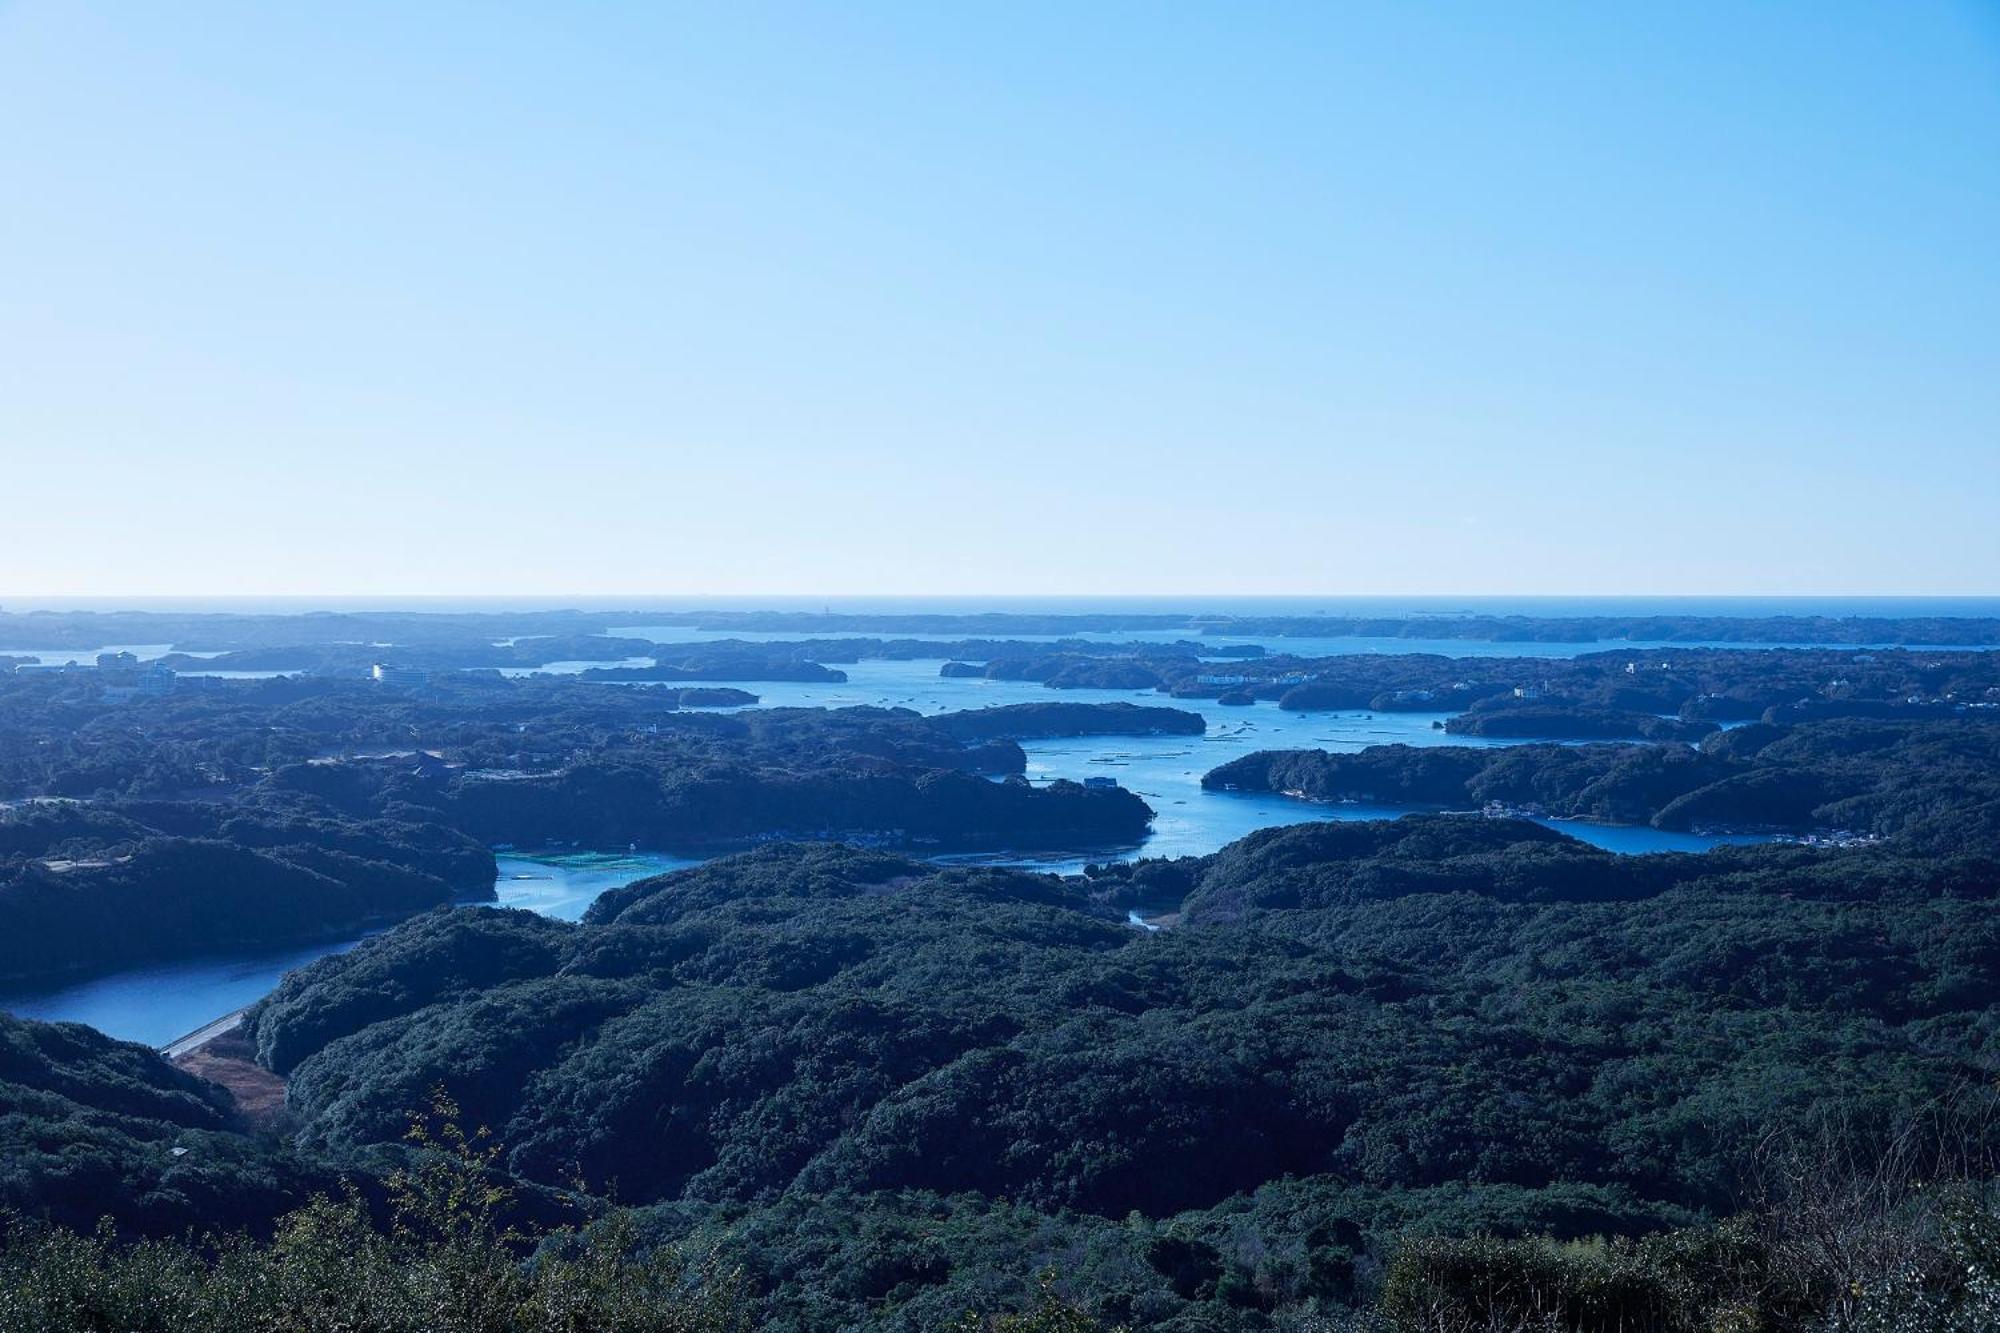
[0,673,1168,981]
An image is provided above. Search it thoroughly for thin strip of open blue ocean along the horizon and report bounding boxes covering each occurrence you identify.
[11,594,2000,618]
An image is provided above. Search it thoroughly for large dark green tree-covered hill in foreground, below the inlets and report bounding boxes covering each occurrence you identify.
[252,817,2000,1272]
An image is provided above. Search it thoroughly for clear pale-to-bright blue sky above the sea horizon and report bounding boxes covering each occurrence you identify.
[0,0,2000,600]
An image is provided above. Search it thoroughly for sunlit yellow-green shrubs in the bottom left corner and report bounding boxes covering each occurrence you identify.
[0,1095,750,1333]
